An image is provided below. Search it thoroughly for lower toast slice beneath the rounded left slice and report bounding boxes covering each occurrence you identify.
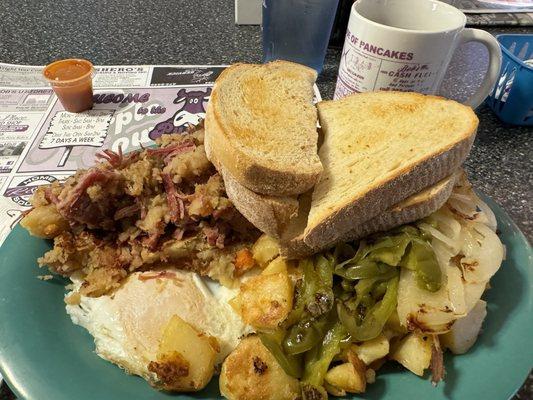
[204,124,298,239]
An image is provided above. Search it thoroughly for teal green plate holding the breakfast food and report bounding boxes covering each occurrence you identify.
[0,195,533,400]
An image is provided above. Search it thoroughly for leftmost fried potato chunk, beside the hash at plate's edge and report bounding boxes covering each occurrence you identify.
[20,204,69,239]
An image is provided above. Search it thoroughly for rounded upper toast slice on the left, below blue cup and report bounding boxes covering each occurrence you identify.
[205,61,322,196]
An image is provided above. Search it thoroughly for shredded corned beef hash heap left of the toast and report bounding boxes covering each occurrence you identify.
[22,125,259,296]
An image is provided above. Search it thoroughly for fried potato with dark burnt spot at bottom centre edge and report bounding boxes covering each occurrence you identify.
[220,336,300,400]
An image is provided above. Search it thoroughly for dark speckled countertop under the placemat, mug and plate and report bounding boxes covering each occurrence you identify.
[0,0,533,399]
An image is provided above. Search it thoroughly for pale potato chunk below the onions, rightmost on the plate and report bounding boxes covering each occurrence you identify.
[439,300,487,354]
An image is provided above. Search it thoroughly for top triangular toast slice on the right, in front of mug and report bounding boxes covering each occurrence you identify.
[304,92,478,248]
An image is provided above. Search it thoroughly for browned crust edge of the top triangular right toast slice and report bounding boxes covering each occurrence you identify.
[304,93,478,249]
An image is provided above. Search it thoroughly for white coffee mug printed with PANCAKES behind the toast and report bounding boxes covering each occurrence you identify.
[334,0,502,108]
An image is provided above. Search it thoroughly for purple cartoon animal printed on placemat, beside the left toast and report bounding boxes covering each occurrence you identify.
[148,88,211,140]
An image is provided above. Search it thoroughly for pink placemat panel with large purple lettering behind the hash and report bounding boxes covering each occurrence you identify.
[16,86,210,173]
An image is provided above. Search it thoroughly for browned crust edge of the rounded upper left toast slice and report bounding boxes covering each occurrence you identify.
[205,61,322,196]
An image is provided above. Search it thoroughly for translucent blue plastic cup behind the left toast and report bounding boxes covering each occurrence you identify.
[263,0,339,72]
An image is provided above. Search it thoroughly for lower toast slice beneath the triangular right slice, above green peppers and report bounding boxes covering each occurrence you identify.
[281,172,460,258]
